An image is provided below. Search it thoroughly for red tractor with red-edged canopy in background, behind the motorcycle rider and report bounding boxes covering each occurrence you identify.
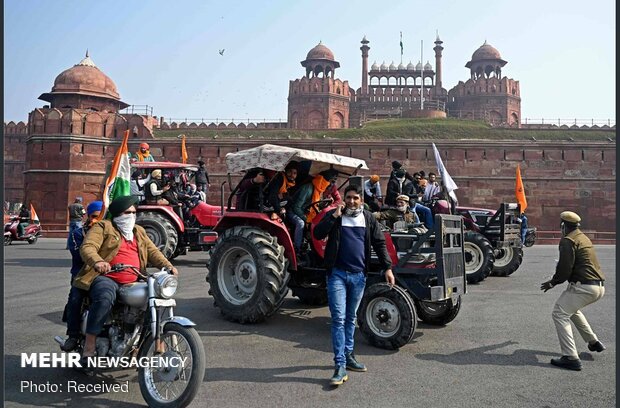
[131,162,222,259]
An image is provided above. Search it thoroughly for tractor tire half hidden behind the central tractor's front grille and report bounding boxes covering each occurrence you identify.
[463,231,495,283]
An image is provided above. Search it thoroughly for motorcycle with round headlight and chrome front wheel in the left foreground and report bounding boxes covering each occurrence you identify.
[54,264,206,407]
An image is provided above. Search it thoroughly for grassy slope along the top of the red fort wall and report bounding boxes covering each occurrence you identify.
[154,119,616,142]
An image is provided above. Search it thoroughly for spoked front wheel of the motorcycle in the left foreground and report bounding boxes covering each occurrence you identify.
[138,323,206,408]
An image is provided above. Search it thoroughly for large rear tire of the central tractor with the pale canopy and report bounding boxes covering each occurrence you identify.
[208,226,290,323]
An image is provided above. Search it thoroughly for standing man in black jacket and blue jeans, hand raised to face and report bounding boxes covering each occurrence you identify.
[314,185,395,385]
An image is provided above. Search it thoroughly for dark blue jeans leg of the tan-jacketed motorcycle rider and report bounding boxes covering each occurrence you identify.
[86,275,119,335]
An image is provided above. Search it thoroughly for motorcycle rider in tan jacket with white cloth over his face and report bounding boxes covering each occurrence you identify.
[73,196,178,357]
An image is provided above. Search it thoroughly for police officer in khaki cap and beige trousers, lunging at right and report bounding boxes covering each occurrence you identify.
[540,211,605,371]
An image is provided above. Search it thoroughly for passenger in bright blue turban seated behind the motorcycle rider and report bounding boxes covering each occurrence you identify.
[60,201,103,351]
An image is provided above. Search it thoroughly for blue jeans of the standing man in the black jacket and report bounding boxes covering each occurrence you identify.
[327,267,366,367]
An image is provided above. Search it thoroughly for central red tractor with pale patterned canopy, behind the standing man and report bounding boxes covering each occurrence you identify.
[206,145,466,349]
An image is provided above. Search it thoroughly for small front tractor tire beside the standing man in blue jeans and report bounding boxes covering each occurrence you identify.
[357,283,418,350]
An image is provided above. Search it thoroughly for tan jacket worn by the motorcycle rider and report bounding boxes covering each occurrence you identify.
[73,220,172,290]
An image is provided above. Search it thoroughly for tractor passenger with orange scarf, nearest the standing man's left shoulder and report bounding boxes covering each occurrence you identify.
[286,170,338,254]
